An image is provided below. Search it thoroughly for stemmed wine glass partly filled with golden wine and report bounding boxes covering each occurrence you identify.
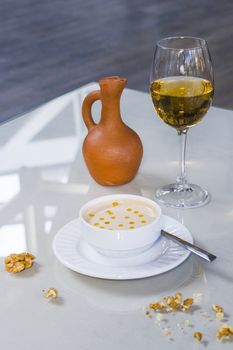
[150,37,214,208]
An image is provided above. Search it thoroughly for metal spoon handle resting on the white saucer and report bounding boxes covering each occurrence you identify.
[161,230,217,262]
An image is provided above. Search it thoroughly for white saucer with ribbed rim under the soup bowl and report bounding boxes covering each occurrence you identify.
[53,215,193,280]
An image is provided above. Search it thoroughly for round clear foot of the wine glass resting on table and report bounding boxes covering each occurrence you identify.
[155,183,210,208]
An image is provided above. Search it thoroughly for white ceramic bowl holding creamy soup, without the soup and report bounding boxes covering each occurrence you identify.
[79,194,162,257]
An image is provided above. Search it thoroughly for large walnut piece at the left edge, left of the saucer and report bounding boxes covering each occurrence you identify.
[5,253,35,273]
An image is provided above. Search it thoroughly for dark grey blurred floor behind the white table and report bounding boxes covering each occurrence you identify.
[0,0,233,120]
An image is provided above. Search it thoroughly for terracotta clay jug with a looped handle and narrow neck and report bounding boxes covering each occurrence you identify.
[82,76,143,186]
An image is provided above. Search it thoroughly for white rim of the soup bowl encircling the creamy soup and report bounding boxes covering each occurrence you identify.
[79,193,162,233]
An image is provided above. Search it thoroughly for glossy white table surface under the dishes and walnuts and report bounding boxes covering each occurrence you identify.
[0,84,233,350]
